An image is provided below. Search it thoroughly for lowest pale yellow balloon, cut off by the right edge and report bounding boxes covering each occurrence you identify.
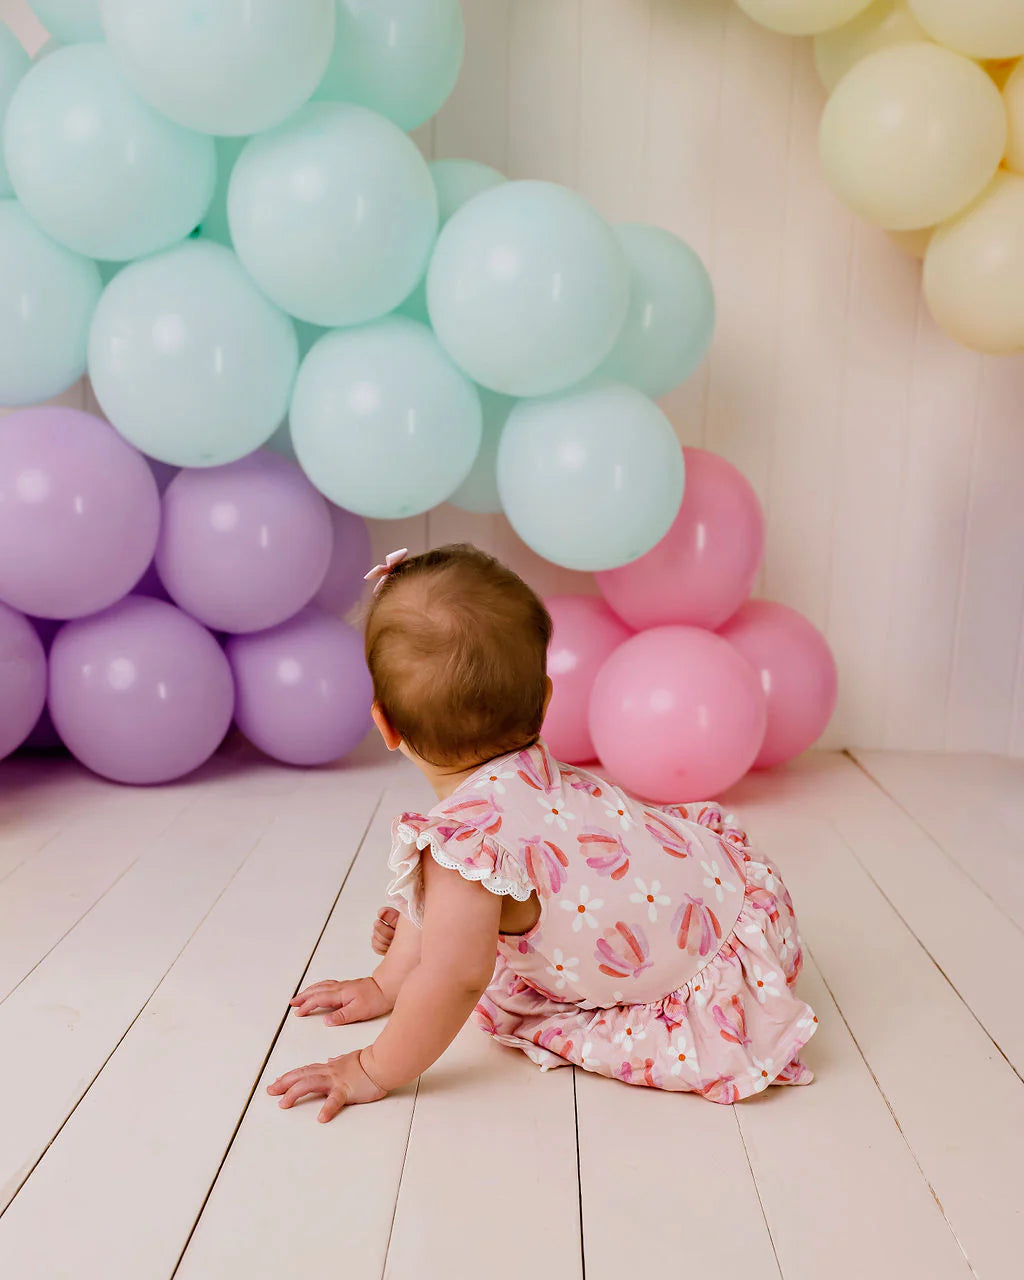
[924,170,1024,355]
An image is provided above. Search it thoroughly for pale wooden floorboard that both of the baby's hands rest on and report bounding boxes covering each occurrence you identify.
[175,767,429,1280]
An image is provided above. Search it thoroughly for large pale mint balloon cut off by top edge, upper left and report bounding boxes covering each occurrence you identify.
[101,0,334,134]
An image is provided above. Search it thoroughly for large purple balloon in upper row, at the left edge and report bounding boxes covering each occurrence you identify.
[0,404,160,618]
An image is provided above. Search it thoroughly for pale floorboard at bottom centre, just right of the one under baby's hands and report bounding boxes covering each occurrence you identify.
[384,1025,582,1280]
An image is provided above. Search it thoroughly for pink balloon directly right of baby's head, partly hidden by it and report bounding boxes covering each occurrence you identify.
[543,595,632,764]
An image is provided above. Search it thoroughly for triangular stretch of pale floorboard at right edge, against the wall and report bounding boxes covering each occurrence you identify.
[855,751,1024,936]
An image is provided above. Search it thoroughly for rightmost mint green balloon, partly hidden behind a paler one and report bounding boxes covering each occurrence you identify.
[600,223,714,398]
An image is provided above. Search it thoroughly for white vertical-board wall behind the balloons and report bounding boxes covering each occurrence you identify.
[0,0,1024,754]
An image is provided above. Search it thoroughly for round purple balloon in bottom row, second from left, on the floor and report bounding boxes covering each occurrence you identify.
[50,595,234,783]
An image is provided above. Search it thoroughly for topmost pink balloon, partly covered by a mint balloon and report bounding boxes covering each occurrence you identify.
[596,449,764,631]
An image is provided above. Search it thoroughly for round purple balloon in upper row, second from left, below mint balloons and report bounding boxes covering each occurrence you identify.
[156,451,332,632]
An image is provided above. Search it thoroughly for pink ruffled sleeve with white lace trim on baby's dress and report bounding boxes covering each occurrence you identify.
[388,813,534,925]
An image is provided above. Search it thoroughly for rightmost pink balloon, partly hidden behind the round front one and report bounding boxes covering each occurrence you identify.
[718,600,838,769]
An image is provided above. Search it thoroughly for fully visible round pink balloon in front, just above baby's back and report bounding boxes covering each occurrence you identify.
[590,627,765,804]
